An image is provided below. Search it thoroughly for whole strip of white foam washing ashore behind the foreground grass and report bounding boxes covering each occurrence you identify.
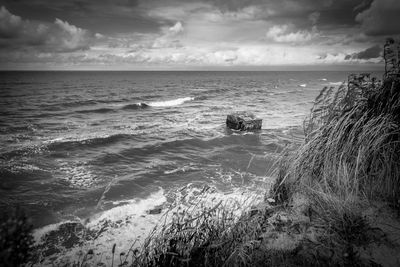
[35,184,262,266]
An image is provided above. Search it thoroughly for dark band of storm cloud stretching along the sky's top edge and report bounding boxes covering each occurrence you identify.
[0,0,370,34]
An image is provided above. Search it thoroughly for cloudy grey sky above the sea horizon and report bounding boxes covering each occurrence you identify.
[0,0,400,70]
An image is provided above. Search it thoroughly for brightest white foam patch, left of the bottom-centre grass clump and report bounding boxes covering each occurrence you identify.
[34,189,166,266]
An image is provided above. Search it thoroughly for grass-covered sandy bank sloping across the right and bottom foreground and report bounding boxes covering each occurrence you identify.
[0,41,400,266]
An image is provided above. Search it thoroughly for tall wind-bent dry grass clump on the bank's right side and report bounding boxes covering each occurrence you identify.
[271,69,400,264]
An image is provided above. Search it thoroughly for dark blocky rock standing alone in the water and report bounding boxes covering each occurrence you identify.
[226,112,262,131]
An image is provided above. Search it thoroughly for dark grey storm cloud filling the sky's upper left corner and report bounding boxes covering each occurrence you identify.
[0,0,160,35]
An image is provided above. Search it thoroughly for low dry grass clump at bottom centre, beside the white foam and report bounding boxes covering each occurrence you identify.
[132,187,263,266]
